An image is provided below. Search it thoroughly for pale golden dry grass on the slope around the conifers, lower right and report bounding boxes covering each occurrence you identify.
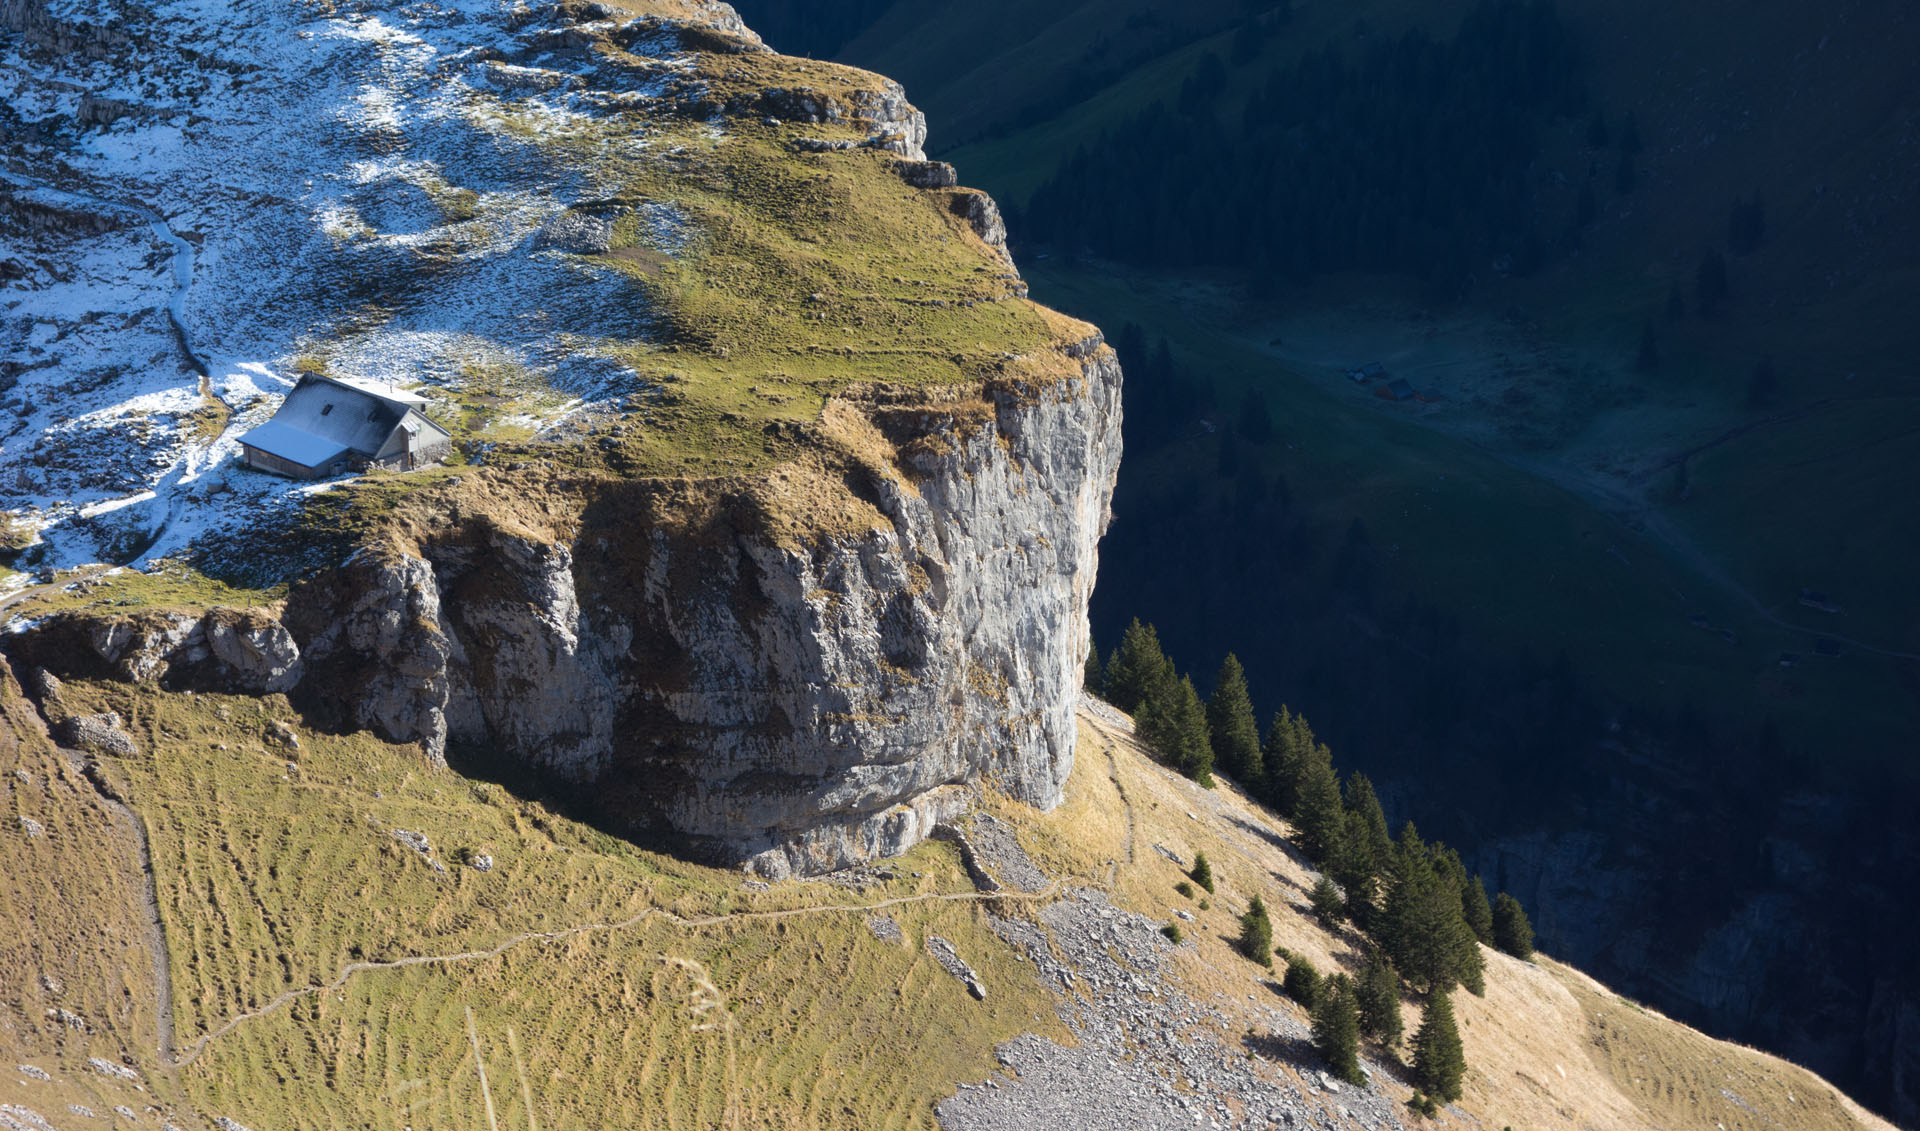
[1029,714,1891,1131]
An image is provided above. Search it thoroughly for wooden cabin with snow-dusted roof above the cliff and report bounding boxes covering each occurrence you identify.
[240,373,453,480]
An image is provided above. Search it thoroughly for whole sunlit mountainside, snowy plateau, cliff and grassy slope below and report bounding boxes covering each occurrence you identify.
[0,2,1904,1131]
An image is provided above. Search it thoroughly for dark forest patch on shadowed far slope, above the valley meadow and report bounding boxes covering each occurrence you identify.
[1016,0,1596,292]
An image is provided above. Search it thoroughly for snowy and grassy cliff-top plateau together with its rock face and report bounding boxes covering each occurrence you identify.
[0,2,1121,878]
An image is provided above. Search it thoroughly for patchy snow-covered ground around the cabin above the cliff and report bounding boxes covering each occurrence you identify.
[0,0,721,566]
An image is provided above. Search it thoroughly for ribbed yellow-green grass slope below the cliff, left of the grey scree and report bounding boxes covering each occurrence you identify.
[0,682,1064,1129]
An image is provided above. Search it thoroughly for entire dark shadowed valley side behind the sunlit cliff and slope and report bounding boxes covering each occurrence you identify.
[741,0,1920,1119]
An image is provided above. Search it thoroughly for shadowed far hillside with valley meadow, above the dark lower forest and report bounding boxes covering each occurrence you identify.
[771,0,1920,771]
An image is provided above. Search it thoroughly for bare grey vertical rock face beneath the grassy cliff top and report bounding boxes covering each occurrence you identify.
[10,338,1121,876]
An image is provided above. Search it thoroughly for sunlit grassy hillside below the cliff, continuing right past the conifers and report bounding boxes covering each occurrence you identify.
[0,649,1880,1129]
